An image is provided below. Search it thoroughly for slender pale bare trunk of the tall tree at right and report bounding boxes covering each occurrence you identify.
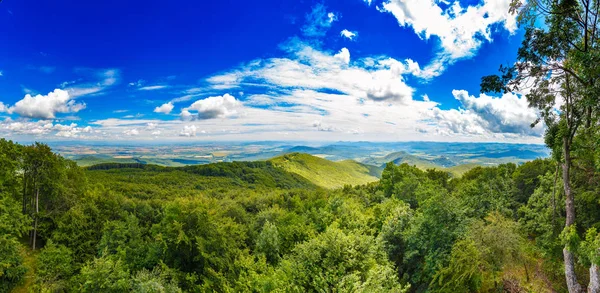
[562,137,583,293]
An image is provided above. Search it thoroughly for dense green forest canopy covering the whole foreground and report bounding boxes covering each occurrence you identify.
[0,139,600,292]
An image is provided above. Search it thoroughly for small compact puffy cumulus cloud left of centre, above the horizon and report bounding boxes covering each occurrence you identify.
[181,94,242,120]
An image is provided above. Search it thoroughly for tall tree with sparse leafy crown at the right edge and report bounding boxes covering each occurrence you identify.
[481,0,600,293]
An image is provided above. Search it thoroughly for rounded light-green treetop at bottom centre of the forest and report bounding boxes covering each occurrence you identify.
[276,227,403,292]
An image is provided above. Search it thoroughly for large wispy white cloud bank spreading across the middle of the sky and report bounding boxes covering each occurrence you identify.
[207,43,436,102]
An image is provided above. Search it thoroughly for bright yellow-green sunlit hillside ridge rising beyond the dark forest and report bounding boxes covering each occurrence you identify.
[269,153,381,188]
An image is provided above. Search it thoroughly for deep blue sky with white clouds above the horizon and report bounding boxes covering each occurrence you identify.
[0,0,543,142]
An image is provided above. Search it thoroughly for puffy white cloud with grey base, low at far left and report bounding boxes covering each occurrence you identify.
[9,89,85,119]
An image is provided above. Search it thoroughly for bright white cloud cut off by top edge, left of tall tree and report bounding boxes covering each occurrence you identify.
[378,0,517,62]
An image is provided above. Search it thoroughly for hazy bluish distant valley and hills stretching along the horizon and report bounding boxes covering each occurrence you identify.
[53,142,549,178]
